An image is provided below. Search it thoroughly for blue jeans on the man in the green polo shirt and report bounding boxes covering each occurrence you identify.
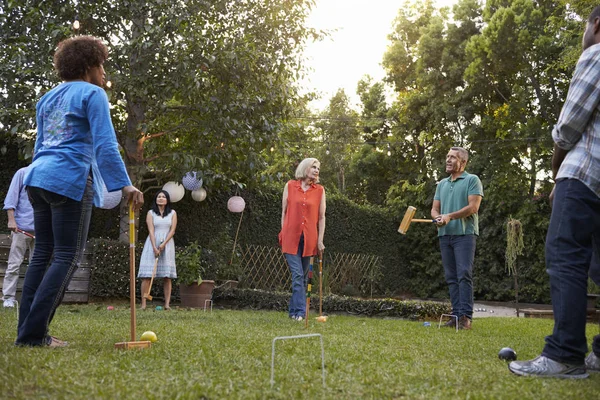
[440,235,477,318]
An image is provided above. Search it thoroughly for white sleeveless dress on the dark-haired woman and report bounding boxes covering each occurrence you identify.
[138,210,177,279]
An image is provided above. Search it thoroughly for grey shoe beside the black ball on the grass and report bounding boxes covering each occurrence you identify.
[508,356,589,379]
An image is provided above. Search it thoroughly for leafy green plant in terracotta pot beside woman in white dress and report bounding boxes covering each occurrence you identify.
[175,242,215,308]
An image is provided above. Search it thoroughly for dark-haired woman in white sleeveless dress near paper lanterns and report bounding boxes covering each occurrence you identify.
[138,190,177,310]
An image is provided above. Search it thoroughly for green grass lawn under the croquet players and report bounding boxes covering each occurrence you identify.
[0,304,600,400]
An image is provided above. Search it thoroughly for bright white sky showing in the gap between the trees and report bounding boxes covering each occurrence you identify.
[301,0,457,110]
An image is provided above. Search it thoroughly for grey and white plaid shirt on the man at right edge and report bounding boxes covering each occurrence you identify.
[552,44,600,197]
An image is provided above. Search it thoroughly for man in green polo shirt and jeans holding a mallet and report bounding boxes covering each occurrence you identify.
[431,147,483,329]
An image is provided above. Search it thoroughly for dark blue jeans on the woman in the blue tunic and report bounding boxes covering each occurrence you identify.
[15,177,94,346]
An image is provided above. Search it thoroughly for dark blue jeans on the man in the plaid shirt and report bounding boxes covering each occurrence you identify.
[542,179,600,364]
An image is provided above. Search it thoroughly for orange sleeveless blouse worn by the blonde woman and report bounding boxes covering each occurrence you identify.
[279,180,323,257]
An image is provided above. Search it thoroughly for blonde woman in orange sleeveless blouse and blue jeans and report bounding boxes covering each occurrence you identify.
[279,158,325,321]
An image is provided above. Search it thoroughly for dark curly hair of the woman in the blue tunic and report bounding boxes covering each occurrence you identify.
[54,36,108,81]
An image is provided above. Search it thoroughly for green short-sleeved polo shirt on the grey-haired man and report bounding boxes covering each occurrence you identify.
[433,171,483,236]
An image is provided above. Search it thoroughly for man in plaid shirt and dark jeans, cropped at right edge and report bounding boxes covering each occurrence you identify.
[509,6,600,379]
